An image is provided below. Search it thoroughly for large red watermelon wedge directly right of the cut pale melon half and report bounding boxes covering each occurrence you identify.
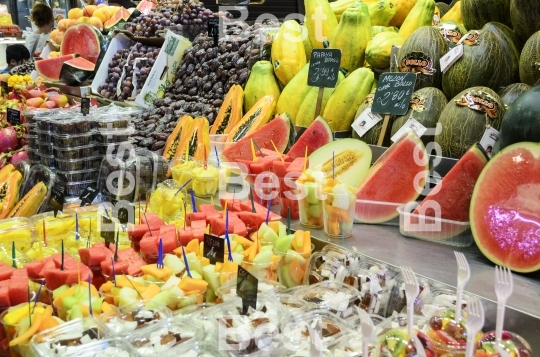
[355,130,429,223]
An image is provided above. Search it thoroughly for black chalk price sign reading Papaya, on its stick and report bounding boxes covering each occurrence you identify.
[308,49,341,119]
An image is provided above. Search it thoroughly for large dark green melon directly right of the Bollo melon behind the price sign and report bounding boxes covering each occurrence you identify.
[442,30,507,98]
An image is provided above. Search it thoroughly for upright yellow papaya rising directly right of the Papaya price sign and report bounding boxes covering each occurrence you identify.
[330,1,371,72]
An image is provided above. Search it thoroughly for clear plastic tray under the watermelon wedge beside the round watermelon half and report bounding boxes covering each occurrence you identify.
[398,202,474,247]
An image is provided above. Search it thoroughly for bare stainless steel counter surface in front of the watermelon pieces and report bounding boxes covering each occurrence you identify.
[291,222,540,350]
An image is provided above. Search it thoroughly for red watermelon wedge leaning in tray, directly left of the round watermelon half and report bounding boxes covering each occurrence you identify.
[413,144,489,222]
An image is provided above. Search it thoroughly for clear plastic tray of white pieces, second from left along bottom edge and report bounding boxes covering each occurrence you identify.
[128,319,203,357]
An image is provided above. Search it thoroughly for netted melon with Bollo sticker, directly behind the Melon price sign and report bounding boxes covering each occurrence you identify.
[398,26,448,90]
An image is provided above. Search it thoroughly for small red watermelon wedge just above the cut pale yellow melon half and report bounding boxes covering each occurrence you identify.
[287,116,334,159]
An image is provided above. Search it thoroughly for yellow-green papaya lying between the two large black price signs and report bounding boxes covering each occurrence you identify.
[322,68,375,131]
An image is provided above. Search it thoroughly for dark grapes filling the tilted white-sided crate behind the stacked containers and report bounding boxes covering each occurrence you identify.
[98,42,160,102]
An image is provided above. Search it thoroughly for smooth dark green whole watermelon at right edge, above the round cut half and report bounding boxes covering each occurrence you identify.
[494,86,540,152]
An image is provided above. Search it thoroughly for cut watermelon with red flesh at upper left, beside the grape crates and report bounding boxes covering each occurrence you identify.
[58,24,103,64]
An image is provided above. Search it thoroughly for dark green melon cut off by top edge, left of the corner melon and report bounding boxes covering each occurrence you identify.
[461,0,512,31]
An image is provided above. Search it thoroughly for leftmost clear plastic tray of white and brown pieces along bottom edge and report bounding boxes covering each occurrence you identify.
[30,317,109,357]
